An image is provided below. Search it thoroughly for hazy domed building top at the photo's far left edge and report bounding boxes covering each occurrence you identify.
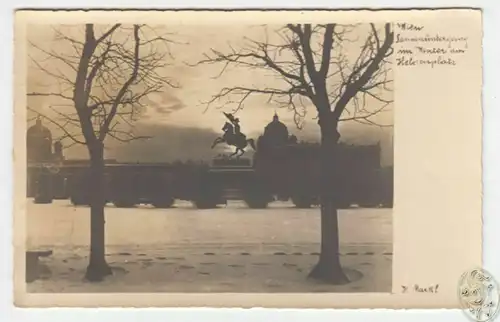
[26,118,52,162]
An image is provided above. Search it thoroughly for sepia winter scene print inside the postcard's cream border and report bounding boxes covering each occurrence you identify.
[23,21,397,293]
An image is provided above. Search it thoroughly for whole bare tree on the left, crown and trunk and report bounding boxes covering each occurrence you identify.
[28,24,175,281]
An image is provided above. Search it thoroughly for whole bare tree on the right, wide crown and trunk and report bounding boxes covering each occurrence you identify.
[195,24,394,284]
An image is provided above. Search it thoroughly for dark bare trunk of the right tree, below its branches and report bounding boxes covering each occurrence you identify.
[309,112,349,284]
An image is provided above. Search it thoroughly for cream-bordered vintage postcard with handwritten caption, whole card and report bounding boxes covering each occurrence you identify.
[14,9,482,308]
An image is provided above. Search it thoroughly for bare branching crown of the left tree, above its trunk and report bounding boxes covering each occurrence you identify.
[28,24,177,149]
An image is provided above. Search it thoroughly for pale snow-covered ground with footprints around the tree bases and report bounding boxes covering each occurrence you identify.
[27,200,392,292]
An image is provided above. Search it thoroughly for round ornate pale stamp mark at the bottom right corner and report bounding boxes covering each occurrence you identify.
[458,268,500,322]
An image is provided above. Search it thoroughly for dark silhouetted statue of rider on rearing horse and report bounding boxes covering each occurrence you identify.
[212,112,256,158]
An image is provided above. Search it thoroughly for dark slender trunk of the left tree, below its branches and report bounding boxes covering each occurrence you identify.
[85,140,112,282]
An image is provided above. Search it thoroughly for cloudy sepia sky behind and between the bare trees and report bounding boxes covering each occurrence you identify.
[27,24,393,164]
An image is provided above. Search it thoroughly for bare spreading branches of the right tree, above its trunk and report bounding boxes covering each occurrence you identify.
[195,24,393,131]
